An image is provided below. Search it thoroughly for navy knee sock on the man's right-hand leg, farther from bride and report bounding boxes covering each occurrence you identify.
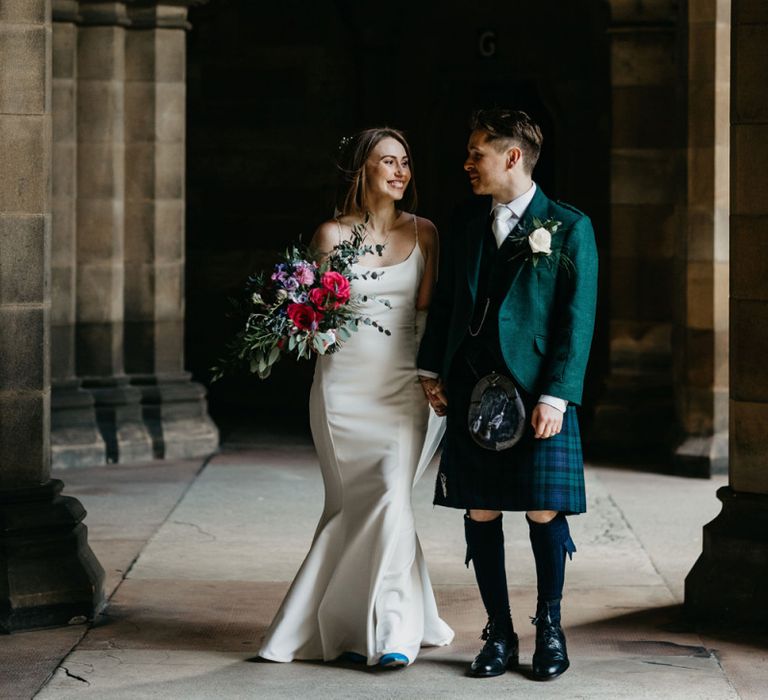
[526,513,576,624]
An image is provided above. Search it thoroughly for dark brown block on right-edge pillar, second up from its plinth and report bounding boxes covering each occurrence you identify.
[731,299,768,402]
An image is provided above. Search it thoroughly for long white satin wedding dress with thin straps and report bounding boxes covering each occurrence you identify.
[260,218,453,665]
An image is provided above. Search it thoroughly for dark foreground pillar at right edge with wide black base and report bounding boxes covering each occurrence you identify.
[685,2,768,629]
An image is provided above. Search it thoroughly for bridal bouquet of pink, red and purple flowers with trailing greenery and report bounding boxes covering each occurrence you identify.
[211,224,390,381]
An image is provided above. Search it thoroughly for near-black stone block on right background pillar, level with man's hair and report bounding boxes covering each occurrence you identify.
[611,85,685,148]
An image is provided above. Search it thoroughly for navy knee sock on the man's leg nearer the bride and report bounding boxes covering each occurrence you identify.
[464,514,510,623]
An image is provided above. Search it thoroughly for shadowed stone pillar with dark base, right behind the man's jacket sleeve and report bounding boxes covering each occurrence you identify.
[590,0,686,468]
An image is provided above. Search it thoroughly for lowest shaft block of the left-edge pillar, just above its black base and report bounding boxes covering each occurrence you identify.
[0,388,50,489]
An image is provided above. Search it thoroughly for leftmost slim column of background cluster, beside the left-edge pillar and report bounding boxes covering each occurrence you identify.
[51,0,107,467]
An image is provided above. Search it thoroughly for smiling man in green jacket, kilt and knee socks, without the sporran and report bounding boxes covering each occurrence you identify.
[418,109,597,680]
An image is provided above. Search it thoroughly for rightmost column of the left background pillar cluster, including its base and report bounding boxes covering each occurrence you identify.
[125,4,219,458]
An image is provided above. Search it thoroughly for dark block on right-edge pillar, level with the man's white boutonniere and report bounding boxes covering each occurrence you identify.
[731,216,768,301]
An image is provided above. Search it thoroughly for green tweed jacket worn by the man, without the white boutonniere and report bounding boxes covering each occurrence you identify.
[418,188,597,404]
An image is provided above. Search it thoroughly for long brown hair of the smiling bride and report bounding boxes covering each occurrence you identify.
[336,127,416,216]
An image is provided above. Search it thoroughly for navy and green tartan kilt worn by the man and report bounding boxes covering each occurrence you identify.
[434,348,587,514]
